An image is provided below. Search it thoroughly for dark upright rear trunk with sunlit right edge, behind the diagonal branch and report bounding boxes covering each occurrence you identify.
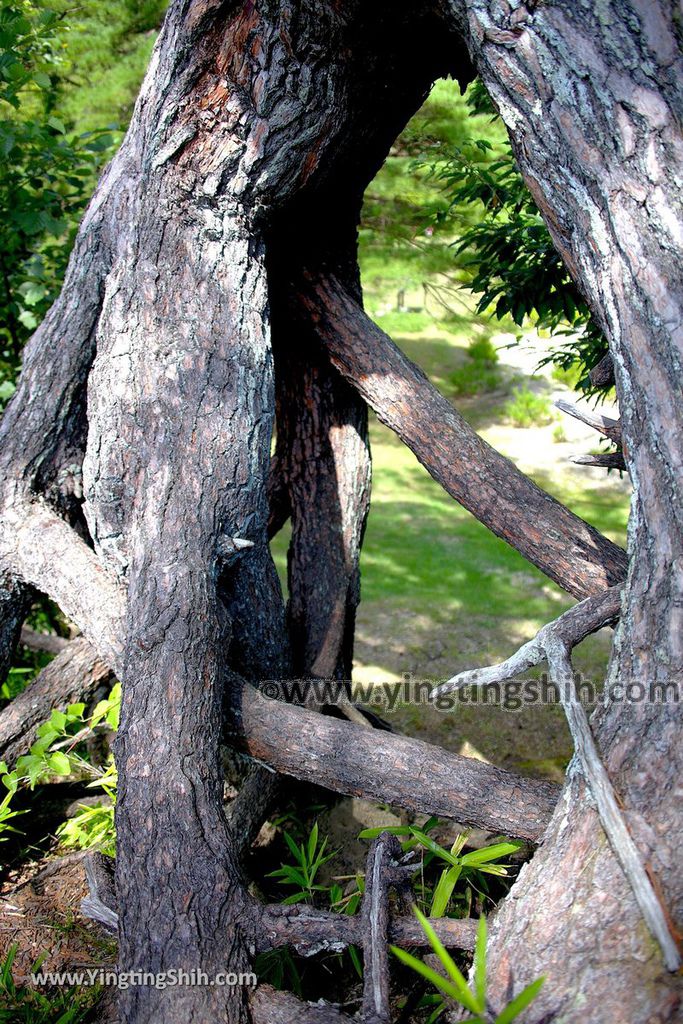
[271,299,370,679]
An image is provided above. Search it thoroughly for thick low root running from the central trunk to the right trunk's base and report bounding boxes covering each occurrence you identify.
[228,686,558,842]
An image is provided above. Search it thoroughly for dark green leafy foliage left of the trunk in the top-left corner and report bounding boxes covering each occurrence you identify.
[0,0,113,403]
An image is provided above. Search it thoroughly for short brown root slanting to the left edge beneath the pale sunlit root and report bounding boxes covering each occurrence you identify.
[0,637,114,768]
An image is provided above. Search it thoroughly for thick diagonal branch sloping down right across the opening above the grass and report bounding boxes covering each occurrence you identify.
[296,278,627,598]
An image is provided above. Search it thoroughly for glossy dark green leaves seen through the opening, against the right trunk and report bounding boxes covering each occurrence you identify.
[430,77,607,390]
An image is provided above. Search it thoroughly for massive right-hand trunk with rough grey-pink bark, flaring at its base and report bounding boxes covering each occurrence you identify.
[432,0,683,1024]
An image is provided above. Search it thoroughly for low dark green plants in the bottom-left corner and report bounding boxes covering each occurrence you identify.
[0,943,100,1024]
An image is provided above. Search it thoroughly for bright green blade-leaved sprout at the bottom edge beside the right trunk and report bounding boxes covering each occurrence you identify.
[391,907,545,1024]
